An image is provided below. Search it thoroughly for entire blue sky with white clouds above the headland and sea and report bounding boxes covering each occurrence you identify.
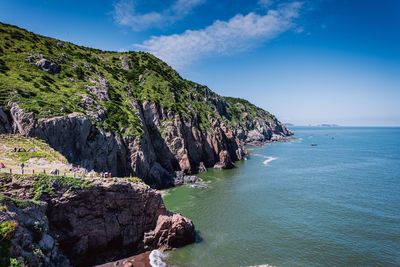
[0,0,400,126]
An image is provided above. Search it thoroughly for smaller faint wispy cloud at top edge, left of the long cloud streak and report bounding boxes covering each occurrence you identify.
[113,0,206,31]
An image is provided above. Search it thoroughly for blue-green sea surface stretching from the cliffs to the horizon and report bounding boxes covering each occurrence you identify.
[164,127,400,267]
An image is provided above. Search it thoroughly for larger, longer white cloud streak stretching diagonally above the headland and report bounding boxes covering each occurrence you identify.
[135,2,302,67]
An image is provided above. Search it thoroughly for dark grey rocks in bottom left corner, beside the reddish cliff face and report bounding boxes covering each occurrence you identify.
[0,196,71,267]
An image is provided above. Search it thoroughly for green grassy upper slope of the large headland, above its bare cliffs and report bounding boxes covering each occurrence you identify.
[0,24,274,136]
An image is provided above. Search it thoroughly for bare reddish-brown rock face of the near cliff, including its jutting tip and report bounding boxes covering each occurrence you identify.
[48,181,195,266]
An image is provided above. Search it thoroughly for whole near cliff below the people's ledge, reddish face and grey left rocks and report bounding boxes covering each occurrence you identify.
[0,174,195,266]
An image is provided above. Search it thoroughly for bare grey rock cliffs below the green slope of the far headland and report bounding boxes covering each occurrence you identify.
[0,99,290,188]
